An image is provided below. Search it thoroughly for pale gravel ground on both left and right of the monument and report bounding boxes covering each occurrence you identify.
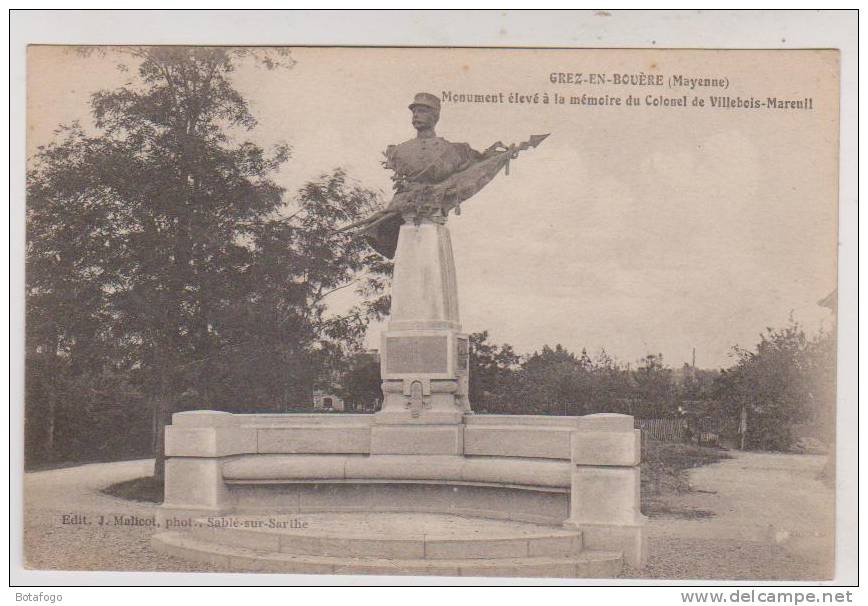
[24,452,834,580]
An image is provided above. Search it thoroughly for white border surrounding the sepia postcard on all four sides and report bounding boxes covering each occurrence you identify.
[7,10,858,588]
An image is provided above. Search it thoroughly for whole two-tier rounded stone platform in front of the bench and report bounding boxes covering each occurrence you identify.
[153,513,623,578]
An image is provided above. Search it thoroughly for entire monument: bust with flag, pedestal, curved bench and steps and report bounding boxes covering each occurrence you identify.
[153,93,645,578]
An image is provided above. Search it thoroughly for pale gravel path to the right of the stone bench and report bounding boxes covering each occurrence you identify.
[643,452,835,580]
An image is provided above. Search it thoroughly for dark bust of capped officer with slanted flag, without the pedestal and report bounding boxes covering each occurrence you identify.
[342,93,548,259]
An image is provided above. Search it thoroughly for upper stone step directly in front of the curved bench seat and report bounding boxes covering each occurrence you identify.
[191,514,582,560]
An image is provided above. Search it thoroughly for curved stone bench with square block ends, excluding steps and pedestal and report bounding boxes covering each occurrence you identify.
[161,411,645,568]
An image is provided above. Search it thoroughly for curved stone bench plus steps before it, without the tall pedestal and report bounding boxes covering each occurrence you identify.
[153,408,646,577]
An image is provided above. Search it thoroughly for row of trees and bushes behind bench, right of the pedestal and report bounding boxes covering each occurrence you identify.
[471,320,836,450]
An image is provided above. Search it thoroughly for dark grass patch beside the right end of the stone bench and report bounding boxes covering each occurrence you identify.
[641,439,732,519]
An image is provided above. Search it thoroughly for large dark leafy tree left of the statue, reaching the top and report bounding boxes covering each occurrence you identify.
[27,47,390,477]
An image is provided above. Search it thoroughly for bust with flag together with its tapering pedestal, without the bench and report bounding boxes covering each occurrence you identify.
[343,93,548,428]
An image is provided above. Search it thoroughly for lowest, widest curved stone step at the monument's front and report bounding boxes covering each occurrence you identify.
[152,532,623,578]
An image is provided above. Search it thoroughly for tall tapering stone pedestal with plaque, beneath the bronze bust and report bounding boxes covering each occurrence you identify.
[371,217,470,455]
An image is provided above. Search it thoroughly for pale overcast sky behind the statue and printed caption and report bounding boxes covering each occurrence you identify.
[28,47,838,367]
